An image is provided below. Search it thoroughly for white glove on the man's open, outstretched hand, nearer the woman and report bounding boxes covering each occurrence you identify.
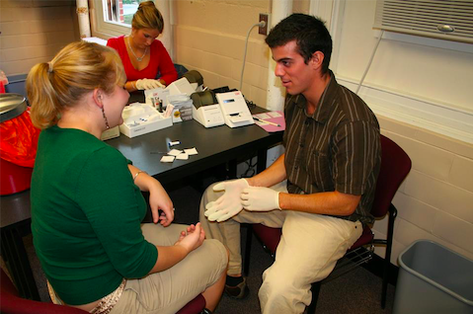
[204,179,250,222]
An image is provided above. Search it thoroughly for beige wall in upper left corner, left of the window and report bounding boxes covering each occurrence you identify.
[0,0,79,76]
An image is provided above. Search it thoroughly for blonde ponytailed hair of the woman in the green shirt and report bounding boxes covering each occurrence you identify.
[26,41,126,129]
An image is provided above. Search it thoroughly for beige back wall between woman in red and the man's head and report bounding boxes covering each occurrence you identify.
[174,0,309,107]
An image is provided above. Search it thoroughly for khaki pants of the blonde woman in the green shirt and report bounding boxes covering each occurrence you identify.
[110,224,227,314]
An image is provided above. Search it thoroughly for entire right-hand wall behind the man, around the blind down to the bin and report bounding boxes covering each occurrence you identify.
[334,0,473,263]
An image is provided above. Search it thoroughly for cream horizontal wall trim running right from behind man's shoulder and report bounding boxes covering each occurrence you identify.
[337,77,473,144]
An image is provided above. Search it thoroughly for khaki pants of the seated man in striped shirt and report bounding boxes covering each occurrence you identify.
[200,185,362,314]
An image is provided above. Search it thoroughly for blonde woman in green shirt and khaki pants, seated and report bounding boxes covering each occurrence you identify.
[27,42,228,314]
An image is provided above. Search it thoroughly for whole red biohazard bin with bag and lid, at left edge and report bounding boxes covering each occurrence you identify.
[0,93,40,195]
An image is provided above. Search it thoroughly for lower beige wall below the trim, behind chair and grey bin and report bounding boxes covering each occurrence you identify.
[374,116,473,263]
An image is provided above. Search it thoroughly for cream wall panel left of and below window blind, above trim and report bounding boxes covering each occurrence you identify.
[336,0,473,111]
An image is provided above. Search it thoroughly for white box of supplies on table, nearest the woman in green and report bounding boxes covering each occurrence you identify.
[120,103,172,138]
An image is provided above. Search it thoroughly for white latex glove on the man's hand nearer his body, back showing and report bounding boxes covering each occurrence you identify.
[241,187,281,211]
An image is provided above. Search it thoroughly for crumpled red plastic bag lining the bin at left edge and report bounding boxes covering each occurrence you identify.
[0,107,41,168]
